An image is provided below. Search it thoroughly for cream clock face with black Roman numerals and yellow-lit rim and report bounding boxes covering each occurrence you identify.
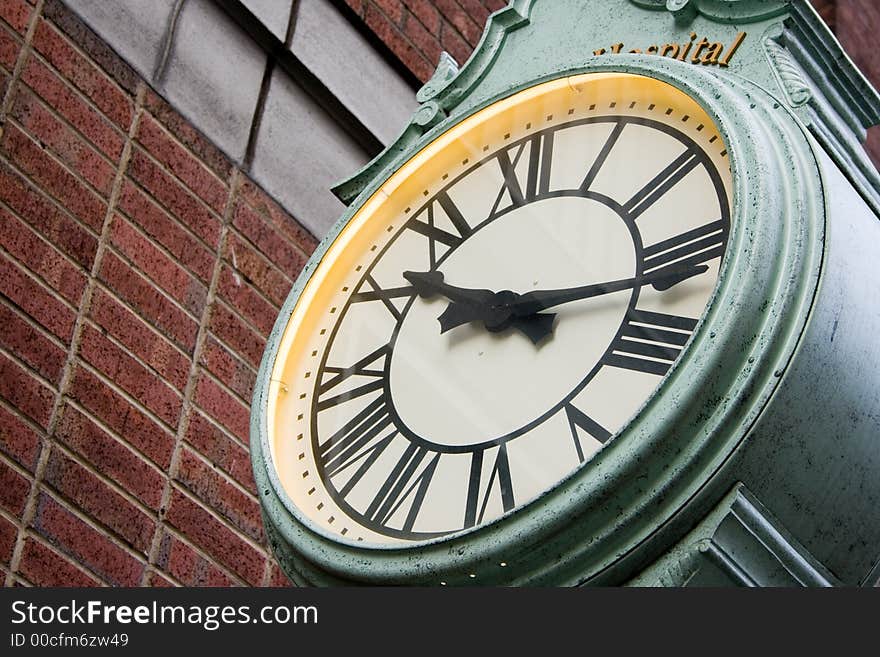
[268,74,731,544]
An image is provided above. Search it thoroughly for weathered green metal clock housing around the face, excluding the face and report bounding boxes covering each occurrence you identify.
[251,0,880,585]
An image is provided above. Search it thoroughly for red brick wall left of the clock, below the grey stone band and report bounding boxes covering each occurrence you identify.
[0,0,315,586]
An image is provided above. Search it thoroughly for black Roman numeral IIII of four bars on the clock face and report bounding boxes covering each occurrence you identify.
[603,310,697,376]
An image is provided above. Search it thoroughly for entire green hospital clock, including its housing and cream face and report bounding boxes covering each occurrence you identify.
[250,0,880,585]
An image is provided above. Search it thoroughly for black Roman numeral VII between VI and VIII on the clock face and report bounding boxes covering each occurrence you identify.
[364,443,440,531]
